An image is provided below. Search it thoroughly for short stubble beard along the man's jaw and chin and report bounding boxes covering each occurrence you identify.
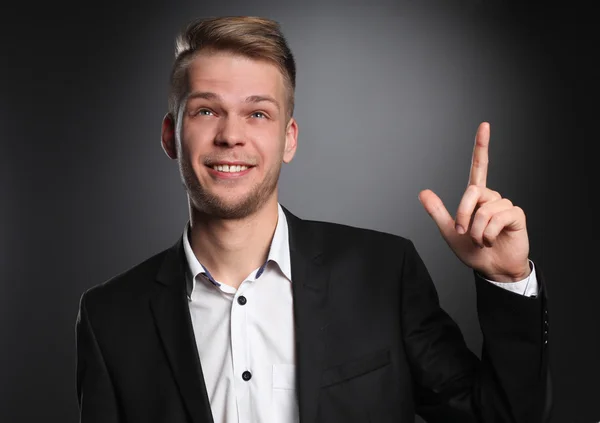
[179,160,281,219]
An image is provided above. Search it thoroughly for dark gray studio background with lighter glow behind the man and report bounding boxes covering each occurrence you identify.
[0,0,600,423]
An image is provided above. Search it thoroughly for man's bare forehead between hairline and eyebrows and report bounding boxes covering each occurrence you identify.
[187,52,285,100]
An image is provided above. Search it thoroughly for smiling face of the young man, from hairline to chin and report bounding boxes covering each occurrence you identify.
[165,52,297,219]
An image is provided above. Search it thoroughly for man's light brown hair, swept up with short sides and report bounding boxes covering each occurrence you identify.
[169,16,296,119]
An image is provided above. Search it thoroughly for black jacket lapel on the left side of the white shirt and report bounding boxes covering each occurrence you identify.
[151,238,213,423]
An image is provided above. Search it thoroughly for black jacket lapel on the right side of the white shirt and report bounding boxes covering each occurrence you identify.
[283,208,329,423]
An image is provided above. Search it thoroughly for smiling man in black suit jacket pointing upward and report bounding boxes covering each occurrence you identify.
[77,17,550,423]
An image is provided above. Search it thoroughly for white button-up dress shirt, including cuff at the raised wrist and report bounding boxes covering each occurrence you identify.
[183,205,537,423]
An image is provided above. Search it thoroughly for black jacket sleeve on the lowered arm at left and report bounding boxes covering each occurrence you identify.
[75,294,119,423]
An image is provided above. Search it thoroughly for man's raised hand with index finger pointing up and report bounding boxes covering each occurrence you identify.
[419,122,530,282]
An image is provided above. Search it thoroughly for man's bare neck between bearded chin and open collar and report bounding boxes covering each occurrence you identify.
[189,197,278,289]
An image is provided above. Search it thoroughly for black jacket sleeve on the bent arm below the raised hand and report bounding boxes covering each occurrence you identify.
[401,241,551,423]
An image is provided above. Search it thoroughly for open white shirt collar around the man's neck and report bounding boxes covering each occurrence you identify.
[183,204,292,295]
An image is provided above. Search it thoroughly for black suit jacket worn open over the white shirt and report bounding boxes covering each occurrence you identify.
[76,209,550,423]
